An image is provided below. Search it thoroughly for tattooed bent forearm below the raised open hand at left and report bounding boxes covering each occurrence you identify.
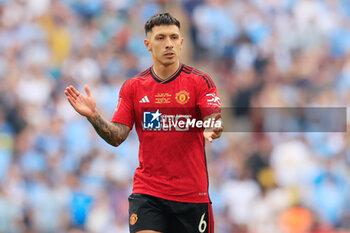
[88,114,130,146]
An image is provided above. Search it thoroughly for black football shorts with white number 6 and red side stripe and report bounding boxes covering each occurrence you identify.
[129,194,214,233]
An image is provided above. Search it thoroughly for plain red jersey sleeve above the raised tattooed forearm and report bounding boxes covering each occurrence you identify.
[112,81,135,128]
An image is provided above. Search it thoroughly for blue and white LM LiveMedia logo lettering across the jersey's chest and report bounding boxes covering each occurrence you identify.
[142,109,221,131]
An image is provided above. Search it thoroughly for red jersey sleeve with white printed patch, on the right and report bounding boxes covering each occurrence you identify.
[197,74,221,118]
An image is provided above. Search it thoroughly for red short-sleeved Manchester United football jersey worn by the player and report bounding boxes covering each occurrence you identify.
[112,64,221,203]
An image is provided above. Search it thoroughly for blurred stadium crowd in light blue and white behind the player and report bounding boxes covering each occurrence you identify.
[0,0,350,233]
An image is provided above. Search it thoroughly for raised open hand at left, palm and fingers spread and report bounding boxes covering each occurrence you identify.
[64,85,97,117]
